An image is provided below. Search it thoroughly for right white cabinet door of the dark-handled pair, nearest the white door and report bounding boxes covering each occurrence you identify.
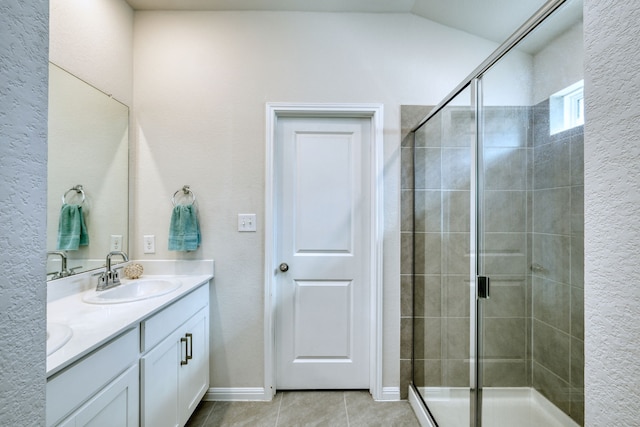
[179,307,209,425]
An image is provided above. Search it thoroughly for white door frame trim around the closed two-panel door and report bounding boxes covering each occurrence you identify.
[264,102,384,400]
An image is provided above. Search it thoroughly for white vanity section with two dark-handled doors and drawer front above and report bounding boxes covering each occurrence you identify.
[140,285,209,427]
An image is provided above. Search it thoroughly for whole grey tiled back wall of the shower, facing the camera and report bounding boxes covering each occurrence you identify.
[402,107,531,398]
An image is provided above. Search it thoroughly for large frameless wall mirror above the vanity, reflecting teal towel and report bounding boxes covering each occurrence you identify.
[47,63,129,280]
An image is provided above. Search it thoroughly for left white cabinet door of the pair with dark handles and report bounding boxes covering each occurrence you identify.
[140,331,181,427]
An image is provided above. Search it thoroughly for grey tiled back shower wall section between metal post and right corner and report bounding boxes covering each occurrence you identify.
[479,107,532,387]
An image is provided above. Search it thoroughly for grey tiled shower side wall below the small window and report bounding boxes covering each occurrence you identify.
[532,101,584,425]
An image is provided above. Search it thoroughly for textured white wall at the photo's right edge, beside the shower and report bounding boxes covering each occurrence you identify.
[584,0,640,427]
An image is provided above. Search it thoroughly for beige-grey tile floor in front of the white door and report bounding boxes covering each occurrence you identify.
[186,391,420,427]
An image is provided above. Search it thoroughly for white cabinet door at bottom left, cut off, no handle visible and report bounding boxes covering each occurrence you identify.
[60,365,139,427]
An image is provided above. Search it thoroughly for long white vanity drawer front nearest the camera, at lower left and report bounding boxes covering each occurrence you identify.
[46,328,139,426]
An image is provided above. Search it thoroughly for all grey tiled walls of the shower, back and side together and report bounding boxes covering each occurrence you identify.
[401,102,583,423]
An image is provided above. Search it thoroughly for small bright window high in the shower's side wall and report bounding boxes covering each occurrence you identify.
[549,80,584,135]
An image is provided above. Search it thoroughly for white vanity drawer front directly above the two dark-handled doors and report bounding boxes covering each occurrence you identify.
[140,282,209,353]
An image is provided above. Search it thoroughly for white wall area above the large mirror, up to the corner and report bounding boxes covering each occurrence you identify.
[49,0,133,106]
